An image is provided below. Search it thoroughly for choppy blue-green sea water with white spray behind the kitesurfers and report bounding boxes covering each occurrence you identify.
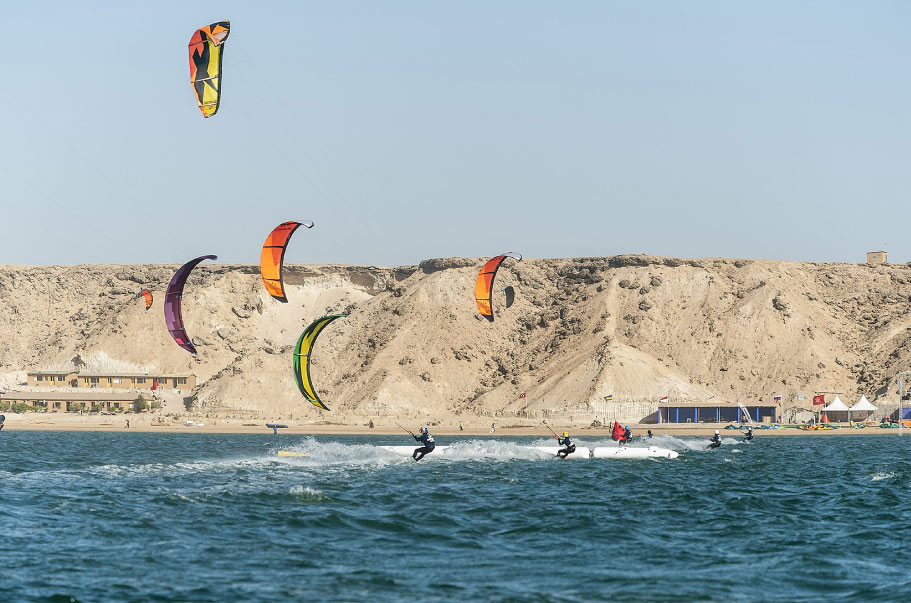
[0,431,911,602]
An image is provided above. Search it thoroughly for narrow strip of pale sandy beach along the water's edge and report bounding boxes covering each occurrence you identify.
[3,413,896,437]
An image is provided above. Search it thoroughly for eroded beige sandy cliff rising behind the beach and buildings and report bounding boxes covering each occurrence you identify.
[0,256,911,421]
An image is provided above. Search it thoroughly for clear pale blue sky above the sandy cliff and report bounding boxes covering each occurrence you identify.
[0,0,911,265]
